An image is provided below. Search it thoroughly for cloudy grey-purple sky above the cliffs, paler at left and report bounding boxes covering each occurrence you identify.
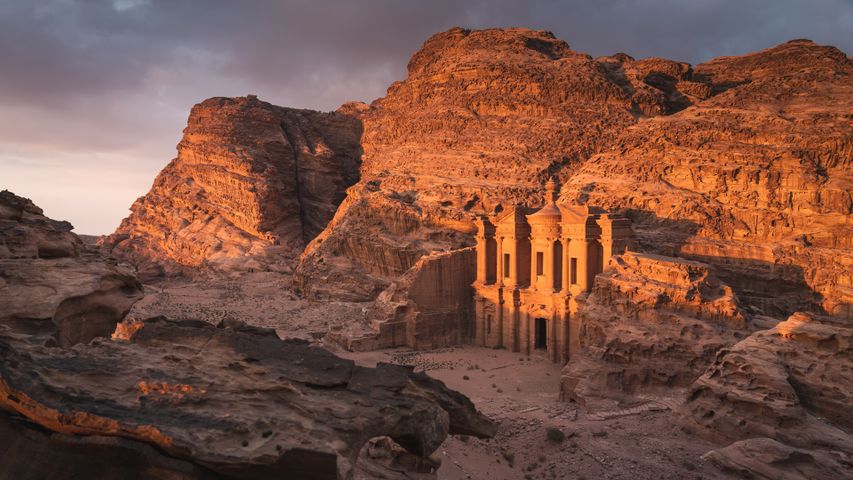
[5,0,853,234]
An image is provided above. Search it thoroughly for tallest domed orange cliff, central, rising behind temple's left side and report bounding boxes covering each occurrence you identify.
[297,28,680,300]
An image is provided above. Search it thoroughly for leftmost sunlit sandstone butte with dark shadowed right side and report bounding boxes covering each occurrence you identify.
[103,95,361,278]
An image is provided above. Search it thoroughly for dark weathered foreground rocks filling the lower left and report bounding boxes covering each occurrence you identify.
[0,191,495,480]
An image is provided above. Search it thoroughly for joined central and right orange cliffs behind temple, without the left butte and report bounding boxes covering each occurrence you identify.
[296,29,853,322]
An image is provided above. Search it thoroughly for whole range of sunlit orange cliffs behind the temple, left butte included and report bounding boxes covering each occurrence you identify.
[105,28,853,317]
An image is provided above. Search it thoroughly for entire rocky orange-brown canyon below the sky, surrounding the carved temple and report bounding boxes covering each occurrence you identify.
[0,28,853,479]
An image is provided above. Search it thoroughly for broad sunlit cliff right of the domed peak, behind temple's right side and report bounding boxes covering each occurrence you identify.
[562,40,853,318]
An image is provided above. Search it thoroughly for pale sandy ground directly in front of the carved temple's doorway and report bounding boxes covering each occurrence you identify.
[336,347,738,480]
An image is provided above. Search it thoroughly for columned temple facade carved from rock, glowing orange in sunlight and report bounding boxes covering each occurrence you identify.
[473,180,633,363]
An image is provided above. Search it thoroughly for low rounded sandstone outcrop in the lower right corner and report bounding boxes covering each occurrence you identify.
[682,313,853,465]
